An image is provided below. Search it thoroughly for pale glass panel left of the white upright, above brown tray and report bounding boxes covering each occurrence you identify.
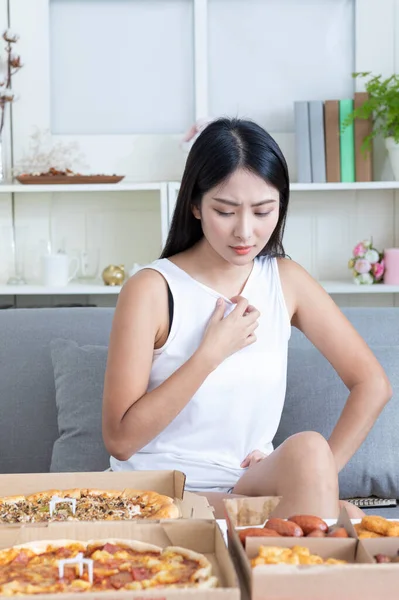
[50,0,194,135]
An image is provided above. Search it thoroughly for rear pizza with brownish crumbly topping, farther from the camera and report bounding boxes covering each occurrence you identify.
[0,489,180,523]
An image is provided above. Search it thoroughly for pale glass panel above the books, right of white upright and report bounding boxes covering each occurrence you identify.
[209,0,355,132]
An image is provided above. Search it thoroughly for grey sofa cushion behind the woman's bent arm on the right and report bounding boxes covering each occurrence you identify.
[274,346,399,498]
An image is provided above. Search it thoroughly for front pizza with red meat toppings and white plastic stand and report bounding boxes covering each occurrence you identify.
[0,539,218,596]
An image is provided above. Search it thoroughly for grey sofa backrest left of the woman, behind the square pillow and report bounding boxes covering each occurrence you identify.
[0,307,114,473]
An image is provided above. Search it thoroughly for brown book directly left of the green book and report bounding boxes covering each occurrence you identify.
[324,100,341,183]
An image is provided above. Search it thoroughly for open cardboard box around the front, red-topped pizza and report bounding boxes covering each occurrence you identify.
[0,519,241,600]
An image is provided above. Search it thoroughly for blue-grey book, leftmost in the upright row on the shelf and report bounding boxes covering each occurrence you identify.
[294,101,312,183]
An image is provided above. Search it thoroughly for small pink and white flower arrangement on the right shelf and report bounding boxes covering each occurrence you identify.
[348,240,385,285]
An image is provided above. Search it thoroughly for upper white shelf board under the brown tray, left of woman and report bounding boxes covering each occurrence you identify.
[0,180,163,194]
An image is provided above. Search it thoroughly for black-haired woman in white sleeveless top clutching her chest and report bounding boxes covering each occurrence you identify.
[103,119,391,518]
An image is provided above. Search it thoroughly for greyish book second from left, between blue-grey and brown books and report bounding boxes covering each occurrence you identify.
[309,100,326,183]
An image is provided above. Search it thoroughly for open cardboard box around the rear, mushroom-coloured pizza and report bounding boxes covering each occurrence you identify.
[0,471,214,527]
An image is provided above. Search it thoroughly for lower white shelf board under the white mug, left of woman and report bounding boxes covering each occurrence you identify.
[0,283,121,296]
